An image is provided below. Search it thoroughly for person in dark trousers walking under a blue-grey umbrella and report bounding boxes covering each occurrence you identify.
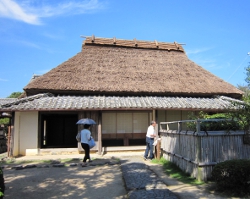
[76,118,96,167]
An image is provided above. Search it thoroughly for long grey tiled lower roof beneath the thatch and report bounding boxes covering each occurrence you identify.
[0,93,240,112]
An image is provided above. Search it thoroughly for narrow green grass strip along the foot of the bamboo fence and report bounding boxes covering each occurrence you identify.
[152,157,205,185]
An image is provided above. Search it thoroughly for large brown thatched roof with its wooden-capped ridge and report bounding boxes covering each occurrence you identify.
[24,37,242,98]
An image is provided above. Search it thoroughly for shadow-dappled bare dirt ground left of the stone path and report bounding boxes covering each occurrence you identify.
[3,159,126,199]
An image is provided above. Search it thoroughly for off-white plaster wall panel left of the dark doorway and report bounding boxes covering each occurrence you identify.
[13,112,38,156]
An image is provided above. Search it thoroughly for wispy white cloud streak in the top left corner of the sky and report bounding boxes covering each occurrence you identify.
[0,0,103,25]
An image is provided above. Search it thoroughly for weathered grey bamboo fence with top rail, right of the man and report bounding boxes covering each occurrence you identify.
[159,119,250,181]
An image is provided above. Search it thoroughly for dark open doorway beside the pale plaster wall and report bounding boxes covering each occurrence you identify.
[41,114,78,148]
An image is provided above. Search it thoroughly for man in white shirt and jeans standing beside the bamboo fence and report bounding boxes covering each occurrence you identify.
[144,121,156,160]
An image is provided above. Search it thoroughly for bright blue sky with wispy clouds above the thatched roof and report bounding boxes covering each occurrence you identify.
[0,0,250,98]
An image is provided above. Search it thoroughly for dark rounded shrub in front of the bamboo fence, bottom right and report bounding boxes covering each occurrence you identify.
[212,159,250,194]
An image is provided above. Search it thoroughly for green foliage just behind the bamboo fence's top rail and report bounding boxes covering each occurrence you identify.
[187,111,241,131]
